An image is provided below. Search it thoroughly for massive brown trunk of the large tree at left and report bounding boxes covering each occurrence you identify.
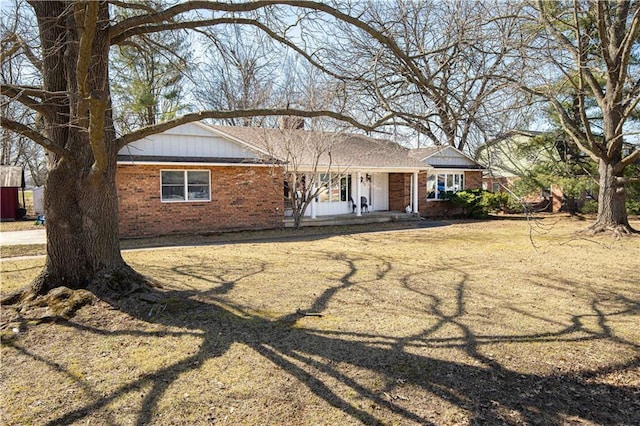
[4,1,146,312]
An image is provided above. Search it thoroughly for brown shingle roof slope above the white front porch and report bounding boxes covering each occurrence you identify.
[211,126,426,170]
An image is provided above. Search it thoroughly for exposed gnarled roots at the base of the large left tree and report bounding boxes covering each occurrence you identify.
[0,264,158,325]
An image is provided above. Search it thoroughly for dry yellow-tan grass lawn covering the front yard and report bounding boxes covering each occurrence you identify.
[0,218,640,425]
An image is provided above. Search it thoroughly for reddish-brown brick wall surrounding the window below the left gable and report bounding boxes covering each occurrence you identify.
[116,164,284,238]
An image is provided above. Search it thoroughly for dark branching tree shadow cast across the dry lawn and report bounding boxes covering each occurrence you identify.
[8,255,640,425]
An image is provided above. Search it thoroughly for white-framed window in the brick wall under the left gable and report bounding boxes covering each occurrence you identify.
[160,170,211,202]
